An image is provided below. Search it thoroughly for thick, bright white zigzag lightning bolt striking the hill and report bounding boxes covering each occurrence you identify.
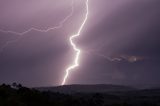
[61,0,89,85]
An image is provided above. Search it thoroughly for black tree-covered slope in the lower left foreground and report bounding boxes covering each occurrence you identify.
[0,83,103,106]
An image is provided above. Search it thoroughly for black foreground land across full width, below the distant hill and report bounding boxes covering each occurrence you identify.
[0,83,160,106]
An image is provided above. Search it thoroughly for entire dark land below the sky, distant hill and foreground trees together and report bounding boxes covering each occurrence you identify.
[0,83,160,106]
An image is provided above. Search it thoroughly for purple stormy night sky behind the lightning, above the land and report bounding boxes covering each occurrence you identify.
[0,0,160,87]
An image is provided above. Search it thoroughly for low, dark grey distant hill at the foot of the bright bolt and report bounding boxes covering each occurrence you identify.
[36,84,136,93]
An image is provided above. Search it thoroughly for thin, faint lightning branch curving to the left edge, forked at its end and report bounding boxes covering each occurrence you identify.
[0,0,74,52]
